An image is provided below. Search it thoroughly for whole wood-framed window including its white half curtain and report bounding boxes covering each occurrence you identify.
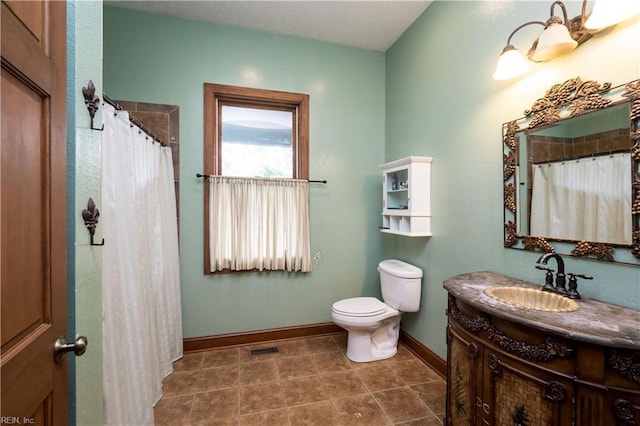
[204,83,310,274]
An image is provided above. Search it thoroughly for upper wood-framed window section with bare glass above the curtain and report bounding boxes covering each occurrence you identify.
[204,83,309,179]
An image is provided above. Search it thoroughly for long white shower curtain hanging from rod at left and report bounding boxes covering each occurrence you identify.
[100,104,182,425]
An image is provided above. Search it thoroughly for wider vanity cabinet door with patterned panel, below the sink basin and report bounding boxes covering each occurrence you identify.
[482,348,574,426]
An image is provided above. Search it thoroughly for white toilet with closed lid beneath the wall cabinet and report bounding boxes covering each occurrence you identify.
[332,259,422,362]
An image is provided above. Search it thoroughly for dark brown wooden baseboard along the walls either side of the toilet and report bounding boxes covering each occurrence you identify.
[182,322,447,378]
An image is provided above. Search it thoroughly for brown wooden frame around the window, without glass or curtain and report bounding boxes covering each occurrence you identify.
[203,83,309,275]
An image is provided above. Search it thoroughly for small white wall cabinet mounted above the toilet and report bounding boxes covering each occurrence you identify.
[380,156,432,237]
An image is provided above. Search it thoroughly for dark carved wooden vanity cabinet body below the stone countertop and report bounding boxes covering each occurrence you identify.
[446,296,640,426]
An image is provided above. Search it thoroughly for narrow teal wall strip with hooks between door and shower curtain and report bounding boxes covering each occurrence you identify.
[67,1,102,425]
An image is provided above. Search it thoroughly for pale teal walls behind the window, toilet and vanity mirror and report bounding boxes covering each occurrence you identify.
[104,1,640,366]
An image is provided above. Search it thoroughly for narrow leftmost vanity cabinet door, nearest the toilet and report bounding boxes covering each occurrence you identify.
[446,324,483,426]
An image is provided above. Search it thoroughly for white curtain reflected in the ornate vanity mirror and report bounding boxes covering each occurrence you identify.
[531,153,631,244]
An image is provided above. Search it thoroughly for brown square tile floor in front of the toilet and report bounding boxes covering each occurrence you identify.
[154,333,445,426]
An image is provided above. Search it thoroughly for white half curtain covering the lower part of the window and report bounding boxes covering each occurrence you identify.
[209,176,311,272]
